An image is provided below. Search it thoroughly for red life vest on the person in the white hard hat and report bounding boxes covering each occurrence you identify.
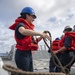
[60,32,75,50]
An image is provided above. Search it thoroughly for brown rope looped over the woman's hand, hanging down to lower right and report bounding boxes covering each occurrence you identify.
[43,31,75,74]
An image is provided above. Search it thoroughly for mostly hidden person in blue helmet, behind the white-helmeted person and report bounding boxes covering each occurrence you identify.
[49,37,61,72]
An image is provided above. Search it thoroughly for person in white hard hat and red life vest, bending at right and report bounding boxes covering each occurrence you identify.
[54,25,75,72]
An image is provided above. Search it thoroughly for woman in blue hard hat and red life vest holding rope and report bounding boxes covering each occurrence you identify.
[9,7,50,72]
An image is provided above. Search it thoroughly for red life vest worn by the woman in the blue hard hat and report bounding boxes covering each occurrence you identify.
[9,18,38,51]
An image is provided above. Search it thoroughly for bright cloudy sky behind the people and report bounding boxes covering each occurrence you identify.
[0,0,75,52]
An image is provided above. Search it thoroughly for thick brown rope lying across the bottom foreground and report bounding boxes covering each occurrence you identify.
[3,64,66,75]
